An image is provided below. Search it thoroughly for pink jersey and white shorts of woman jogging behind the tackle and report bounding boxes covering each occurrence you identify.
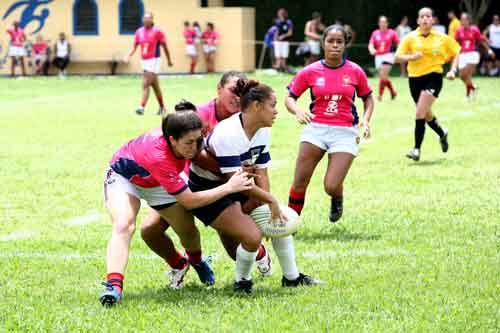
[288,59,372,156]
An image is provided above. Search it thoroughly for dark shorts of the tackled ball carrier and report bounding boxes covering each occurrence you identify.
[188,171,248,226]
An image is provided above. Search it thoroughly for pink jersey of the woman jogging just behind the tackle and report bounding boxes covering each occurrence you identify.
[288,60,372,127]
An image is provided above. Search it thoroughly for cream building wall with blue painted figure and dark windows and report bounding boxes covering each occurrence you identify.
[0,0,255,74]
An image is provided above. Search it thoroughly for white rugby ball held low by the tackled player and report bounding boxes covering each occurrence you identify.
[250,204,300,238]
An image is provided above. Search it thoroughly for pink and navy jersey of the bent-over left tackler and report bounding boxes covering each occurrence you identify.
[109,128,187,195]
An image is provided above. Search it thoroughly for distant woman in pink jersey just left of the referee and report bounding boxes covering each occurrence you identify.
[368,15,399,101]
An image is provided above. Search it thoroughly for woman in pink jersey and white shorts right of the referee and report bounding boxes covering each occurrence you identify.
[455,13,495,100]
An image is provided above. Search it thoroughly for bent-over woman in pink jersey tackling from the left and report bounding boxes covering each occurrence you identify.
[100,102,251,306]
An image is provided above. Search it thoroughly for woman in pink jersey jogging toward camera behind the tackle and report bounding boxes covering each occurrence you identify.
[285,25,374,222]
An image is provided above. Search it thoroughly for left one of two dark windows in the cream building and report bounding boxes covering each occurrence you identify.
[73,0,99,35]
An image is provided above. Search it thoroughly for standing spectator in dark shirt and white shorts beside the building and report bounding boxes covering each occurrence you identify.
[274,8,293,71]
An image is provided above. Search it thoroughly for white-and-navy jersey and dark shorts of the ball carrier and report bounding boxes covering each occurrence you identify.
[189,113,271,226]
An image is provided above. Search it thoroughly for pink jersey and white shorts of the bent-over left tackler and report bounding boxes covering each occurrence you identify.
[104,128,188,210]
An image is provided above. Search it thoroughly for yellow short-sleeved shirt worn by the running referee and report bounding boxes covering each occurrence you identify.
[396,28,460,77]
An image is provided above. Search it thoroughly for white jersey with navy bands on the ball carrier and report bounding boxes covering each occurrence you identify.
[190,113,271,182]
